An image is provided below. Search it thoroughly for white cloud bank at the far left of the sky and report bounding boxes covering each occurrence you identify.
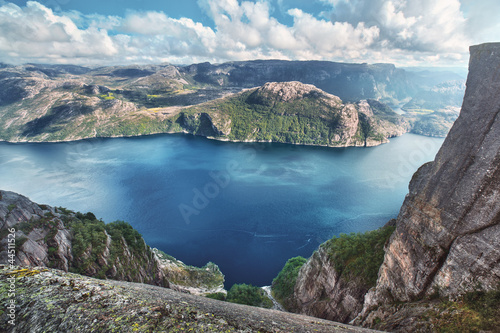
[0,2,118,63]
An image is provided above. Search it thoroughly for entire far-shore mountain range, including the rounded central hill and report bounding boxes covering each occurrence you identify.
[0,60,464,146]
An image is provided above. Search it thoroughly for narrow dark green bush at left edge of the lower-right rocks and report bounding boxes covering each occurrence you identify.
[271,257,307,309]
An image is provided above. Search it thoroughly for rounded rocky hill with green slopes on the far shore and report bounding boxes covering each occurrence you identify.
[177,81,409,147]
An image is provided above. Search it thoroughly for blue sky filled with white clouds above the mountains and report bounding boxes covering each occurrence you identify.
[0,0,500,67]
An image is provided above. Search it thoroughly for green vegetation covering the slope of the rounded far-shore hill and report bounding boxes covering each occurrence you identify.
[181,90,346,145]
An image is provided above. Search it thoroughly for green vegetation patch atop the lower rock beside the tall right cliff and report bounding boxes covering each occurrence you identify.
[321,226,395,289]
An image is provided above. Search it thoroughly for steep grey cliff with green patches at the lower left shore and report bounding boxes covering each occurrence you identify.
[0,191,169,287]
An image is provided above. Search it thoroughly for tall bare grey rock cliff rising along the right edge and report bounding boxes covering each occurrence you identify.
[356,44,500,317]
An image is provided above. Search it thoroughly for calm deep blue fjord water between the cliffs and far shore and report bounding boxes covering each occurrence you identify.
[0,134,443,288]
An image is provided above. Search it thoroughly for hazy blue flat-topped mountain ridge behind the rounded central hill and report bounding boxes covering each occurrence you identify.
[181,60,418,104]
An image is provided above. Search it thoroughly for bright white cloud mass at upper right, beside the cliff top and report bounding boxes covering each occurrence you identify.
[324,0,473,54]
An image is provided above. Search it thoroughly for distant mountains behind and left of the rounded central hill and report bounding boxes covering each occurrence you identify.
[0,60,462,142]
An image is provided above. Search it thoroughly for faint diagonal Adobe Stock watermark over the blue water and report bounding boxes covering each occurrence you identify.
[178,144,266,224]
